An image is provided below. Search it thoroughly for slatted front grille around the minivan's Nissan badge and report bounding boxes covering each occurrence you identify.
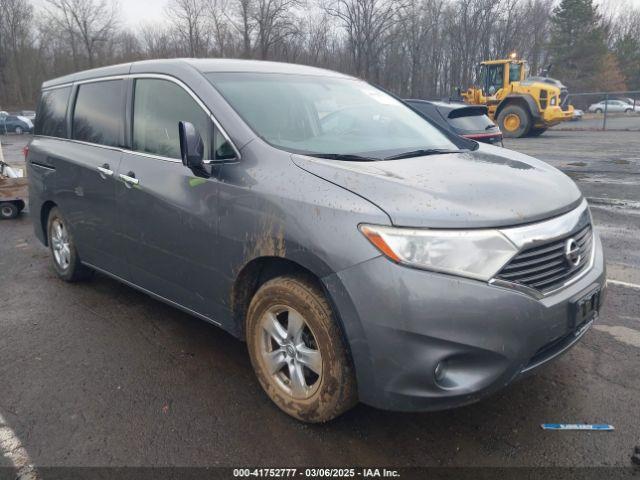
[496,225,593,293]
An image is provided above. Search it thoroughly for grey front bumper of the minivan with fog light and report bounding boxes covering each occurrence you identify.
[324,232,606,411]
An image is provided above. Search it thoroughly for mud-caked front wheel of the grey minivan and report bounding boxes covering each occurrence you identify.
[245,276,358,423]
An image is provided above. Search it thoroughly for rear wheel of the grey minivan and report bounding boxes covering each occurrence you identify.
[47,207,93,282]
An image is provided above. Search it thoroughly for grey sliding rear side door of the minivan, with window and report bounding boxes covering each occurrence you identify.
[56,79,129,279]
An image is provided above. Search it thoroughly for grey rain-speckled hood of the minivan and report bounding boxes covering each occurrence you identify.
[292,144,582,228]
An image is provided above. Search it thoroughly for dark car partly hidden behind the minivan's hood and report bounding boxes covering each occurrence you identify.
[405,99,502,144]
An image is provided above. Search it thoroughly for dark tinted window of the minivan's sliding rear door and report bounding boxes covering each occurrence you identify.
[73,80,124,146]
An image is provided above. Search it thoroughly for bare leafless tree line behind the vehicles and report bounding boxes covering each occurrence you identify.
[0,0,640,110]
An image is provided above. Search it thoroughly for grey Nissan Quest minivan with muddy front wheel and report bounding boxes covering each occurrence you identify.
[27,59,605,422]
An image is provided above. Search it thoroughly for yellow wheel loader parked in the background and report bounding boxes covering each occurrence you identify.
[462,54,573,138]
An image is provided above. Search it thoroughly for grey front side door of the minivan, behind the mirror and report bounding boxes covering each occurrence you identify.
[117,77,232,319]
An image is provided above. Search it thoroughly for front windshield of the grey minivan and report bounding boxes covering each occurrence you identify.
[207,73,457,158]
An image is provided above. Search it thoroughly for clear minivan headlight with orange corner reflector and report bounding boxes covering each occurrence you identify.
[359,225,518,281]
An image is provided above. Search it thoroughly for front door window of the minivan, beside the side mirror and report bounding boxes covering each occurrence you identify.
[133,79,222,159]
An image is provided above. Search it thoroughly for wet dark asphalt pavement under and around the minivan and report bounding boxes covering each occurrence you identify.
[0,131,640,467]
